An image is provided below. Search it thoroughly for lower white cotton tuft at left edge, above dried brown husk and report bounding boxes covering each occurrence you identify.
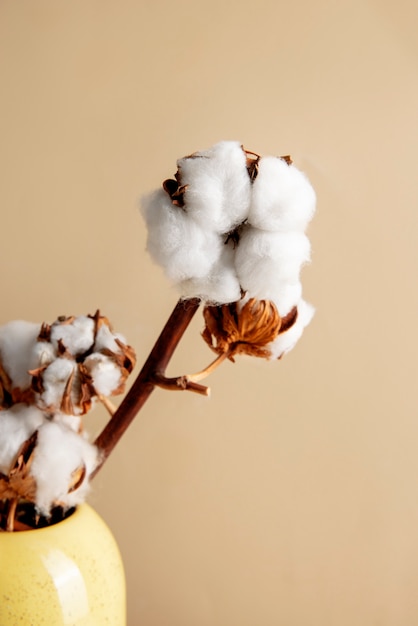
[0,404,45,474]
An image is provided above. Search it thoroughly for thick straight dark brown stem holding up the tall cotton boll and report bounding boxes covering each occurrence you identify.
[93,298,200,475]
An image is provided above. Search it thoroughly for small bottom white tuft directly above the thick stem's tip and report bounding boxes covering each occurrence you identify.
[179,245,241,304]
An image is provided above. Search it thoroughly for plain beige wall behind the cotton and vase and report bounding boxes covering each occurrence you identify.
[0,0,418,626]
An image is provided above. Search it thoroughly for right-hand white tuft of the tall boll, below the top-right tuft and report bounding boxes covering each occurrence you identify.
[235,228,310,300]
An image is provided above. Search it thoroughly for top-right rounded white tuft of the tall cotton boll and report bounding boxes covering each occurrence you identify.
[248,157,316,232]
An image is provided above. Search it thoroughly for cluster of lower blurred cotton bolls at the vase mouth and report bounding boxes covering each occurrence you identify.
[0,312,135,528]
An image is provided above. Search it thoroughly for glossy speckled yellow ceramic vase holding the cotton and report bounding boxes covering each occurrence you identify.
[0,504,126,626]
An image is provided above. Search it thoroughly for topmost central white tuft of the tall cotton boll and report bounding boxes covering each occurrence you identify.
[177,141,251,233]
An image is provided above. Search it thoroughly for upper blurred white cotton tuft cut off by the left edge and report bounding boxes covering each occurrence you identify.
[0,320,40,389]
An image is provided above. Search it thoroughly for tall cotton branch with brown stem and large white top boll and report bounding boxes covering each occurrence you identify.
[96,141,316,450]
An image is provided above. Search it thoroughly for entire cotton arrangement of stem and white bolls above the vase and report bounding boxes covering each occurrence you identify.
[0,141,316,530]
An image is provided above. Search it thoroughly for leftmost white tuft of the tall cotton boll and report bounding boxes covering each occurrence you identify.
[143,189,222,282]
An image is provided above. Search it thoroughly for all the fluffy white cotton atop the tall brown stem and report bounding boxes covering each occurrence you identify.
[143,141,316,354]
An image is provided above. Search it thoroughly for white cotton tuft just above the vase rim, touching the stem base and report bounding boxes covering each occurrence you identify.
[30,422,98,515]
